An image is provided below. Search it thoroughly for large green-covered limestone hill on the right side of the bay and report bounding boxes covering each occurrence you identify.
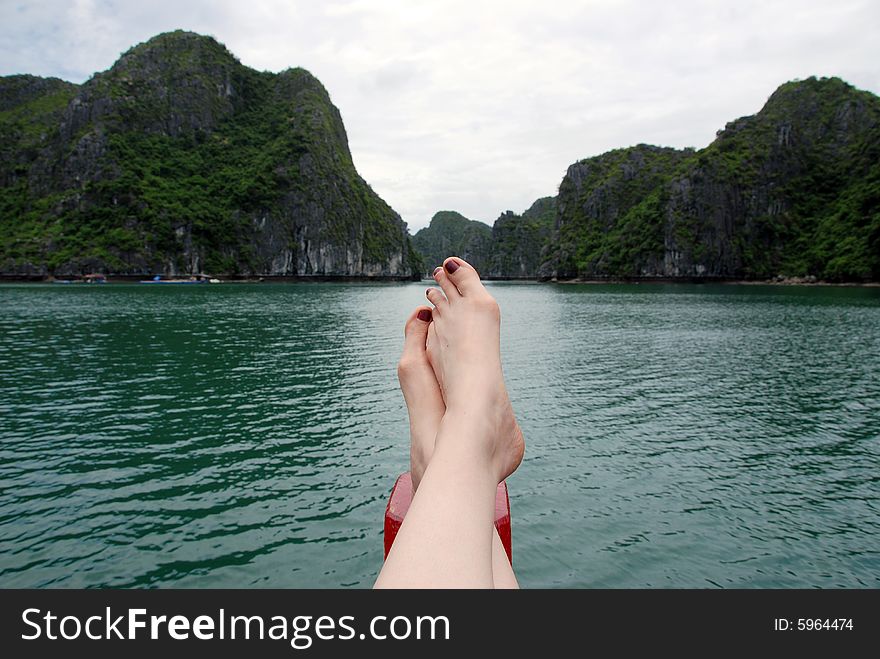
[539,78,880,280]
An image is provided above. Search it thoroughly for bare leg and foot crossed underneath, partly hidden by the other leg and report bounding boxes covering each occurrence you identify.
[397,307,519,588]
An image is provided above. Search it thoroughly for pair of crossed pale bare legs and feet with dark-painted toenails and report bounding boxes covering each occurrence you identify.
[376,257,524,588]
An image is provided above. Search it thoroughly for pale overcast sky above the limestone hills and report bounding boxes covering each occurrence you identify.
[0,0,880,232]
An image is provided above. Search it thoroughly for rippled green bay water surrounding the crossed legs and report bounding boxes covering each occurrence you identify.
[0,283,880,588]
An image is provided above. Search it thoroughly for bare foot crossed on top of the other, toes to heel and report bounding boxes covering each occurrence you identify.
[426,257,525,482]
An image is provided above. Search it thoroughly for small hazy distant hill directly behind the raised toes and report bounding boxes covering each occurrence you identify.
[413,211,492,277]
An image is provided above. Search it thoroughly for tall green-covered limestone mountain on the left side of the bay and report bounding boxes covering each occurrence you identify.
[0,32,421,278]
